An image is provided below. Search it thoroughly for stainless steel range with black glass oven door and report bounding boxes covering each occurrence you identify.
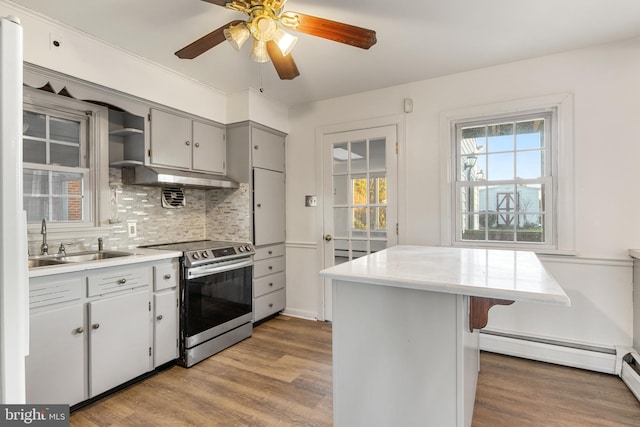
[146,240,255,367]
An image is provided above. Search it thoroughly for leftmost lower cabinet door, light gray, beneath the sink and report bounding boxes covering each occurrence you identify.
[26,304,88,405]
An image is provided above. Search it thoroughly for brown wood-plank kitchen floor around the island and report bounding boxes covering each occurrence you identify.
[71,316,640,427]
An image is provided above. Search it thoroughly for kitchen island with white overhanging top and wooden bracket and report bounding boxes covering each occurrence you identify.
[320,246,570,427]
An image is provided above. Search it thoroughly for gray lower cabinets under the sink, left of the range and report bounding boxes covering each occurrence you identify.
[26,260,178,405]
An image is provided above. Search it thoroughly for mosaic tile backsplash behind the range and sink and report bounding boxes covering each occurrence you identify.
[29,168,251,254]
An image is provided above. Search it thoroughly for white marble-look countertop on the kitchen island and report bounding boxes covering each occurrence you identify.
[320,246,571,306]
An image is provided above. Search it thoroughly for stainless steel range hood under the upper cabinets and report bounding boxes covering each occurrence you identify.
[122,166,240,188]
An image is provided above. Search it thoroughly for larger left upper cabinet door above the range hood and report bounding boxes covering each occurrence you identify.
[151,109,192,169]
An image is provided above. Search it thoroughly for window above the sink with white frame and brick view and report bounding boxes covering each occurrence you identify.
[22,88,109,237]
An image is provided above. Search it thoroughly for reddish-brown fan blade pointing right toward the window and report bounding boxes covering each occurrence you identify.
[281,12,377,49]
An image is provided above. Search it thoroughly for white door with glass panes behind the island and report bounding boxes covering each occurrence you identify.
[322,125,398,320]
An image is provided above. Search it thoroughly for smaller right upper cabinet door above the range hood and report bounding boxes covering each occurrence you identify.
[193,121,227,174]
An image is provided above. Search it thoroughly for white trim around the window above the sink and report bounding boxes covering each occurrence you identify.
[23,87,110,241]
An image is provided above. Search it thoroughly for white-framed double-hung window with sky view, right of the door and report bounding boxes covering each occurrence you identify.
[454,109,556,246]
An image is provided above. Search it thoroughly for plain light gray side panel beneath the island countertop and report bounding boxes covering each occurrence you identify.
[333,280,478,427]
